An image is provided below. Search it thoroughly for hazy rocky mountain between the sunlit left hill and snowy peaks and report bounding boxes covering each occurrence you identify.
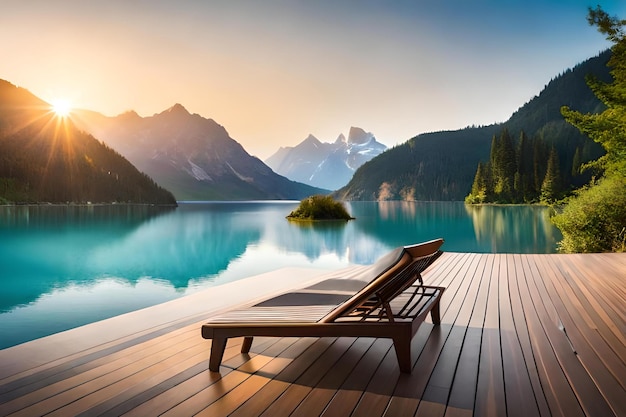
[79,104,328,200]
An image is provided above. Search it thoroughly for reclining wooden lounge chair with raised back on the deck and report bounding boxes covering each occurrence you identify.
[202,239,444,373]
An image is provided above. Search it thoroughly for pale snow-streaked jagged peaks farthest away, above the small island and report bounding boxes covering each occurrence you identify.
[265,127,387,190]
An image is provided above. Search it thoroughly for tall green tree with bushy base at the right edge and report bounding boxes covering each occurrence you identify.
[553,6,626,252]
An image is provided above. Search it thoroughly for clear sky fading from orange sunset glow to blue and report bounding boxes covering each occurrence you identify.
[0,0,626,159]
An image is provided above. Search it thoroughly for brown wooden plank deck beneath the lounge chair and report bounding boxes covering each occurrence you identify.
[0,253,626,417]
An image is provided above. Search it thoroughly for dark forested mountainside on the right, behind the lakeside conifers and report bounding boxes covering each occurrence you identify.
[335,51,610,200]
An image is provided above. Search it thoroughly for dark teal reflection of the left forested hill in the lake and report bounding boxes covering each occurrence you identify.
[0,206,171,311]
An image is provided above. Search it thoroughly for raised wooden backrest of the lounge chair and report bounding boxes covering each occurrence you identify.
[321,239,443,322]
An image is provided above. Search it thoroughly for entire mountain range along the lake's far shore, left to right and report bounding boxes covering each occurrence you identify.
[0,50,610,204]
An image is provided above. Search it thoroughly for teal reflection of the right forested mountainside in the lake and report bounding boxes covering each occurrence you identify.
[350,201,561,253]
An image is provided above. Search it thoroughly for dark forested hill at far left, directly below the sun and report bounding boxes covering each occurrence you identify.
[0,80,176,205]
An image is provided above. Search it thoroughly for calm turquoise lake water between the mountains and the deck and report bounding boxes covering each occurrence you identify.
[0,202,560,348]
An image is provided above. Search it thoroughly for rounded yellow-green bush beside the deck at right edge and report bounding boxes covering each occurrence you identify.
[552,176,626,253]
